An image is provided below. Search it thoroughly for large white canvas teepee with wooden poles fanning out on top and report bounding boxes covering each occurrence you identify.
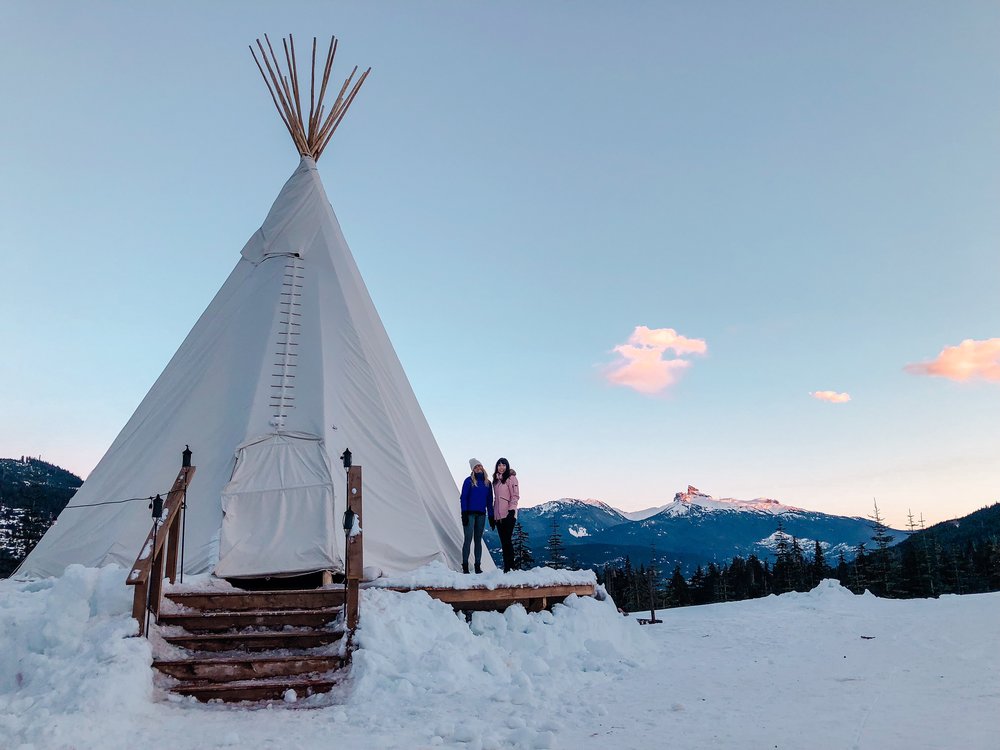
[18,36,493,577]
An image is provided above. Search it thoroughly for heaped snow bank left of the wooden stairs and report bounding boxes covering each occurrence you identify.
[0,565,152,750]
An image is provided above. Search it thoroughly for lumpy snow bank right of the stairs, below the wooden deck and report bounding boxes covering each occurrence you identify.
[349,592,650,749]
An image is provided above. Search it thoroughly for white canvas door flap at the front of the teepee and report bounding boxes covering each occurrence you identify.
[215,432,344,578]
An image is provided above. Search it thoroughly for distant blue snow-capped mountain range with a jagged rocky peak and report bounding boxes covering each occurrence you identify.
[508,486,906,571]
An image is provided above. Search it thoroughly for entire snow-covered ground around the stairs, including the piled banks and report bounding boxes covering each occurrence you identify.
[0,566,1000,750]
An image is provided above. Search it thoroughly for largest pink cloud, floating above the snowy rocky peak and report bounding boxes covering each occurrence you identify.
[605,326,708,394]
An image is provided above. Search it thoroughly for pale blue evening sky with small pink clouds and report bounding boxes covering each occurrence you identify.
[0,0,1000,527]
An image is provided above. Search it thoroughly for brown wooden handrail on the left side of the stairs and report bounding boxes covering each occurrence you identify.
[125,466,195,635]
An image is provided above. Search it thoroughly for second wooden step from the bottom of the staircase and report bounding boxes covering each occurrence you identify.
[153,654,344,682]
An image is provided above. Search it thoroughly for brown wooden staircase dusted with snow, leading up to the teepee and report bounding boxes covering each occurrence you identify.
[153,588,349,702]
